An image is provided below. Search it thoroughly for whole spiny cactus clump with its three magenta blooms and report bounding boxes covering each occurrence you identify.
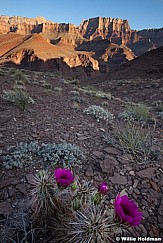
[29,168,142,243]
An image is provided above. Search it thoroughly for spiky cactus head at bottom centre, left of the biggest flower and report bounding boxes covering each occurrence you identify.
[50,203,119,243]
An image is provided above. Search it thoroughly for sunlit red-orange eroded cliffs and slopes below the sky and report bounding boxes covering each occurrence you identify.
[0,16,163,72]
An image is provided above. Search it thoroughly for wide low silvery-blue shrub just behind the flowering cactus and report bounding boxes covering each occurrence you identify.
[4,142,84,169]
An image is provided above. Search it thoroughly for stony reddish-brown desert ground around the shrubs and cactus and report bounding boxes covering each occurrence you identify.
[0,66,163,242]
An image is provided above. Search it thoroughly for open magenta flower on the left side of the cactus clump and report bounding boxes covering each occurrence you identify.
[54,168,74,188]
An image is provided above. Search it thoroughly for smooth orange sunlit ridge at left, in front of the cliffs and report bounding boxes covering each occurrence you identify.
[0,34,99,75]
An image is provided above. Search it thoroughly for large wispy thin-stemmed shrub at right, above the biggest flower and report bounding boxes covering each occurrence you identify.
[116,121,157,163]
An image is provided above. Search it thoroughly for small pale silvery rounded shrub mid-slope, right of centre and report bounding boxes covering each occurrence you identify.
[83,105,114,122]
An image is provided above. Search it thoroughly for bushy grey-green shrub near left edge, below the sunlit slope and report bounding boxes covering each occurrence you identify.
[2,88,34,111]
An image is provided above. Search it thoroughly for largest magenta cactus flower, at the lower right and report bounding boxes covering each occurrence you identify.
[114,194,142,226]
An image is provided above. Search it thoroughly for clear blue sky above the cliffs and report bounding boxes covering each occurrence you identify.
[0,0,163,30]
